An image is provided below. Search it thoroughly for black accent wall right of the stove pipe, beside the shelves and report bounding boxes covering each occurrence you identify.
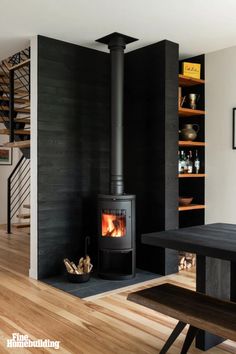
[124,40,179,274]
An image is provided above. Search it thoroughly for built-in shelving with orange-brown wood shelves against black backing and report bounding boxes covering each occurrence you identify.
[178,55,206,227]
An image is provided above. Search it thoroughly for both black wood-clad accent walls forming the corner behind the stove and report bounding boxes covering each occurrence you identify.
[38,36,178,278]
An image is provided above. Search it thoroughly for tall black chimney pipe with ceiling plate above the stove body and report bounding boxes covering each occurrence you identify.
[97,32,137,195]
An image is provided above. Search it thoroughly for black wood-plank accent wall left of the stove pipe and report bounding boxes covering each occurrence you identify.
[38,36,110,278]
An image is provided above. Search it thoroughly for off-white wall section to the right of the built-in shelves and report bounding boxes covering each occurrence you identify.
[205,47,236,223]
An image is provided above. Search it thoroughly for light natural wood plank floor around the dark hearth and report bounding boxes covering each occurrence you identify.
[0,231,236,354]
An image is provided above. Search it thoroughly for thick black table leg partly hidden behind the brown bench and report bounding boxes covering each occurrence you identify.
[196,256,230,350]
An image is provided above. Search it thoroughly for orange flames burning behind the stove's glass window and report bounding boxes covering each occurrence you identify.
[102,210,126,237]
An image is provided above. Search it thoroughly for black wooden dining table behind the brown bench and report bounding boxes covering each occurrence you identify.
[142,223,236,350]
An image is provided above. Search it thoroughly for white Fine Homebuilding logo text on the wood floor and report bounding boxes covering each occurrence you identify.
[7,333,60,349]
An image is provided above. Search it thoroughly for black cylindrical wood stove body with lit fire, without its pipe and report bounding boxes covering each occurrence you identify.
[98,194,135,280]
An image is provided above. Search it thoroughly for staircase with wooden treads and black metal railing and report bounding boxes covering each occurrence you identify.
[0,48,31,233]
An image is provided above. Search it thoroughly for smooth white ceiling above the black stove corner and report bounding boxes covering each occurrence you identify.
[0,0,236,59]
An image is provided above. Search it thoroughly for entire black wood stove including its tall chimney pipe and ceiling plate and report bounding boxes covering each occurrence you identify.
[97,33,136,280]
